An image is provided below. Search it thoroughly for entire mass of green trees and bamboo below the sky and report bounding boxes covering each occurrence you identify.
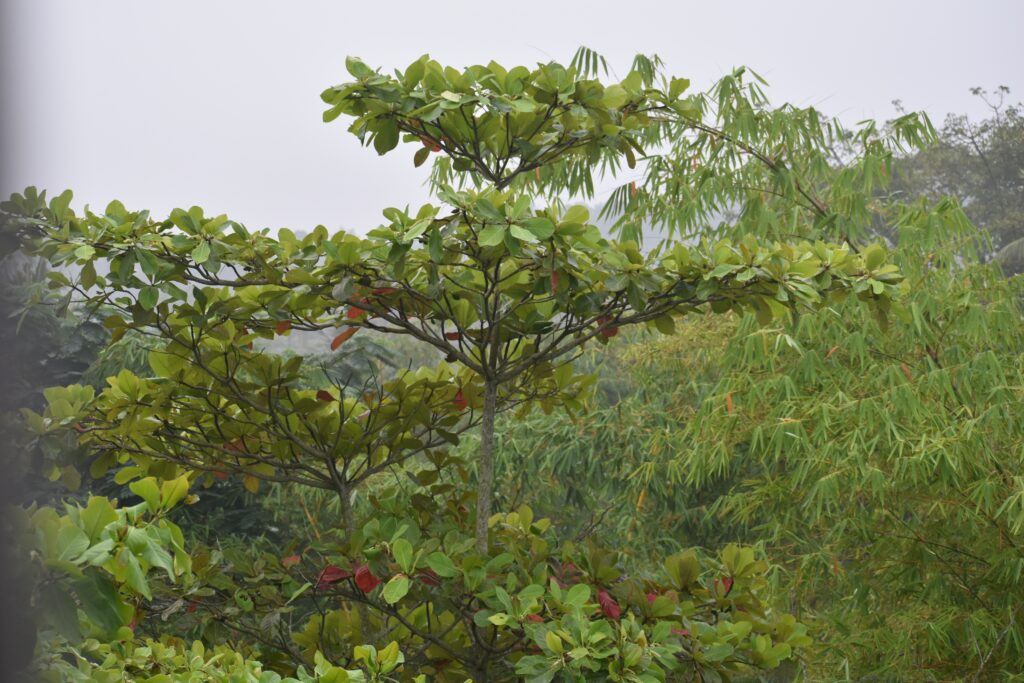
[2,49,1024,682]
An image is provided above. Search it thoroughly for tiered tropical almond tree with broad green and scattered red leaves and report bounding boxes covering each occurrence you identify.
[3,52,901,681]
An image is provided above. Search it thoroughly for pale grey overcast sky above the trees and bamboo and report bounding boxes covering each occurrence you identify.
[0,0,1024,232]
